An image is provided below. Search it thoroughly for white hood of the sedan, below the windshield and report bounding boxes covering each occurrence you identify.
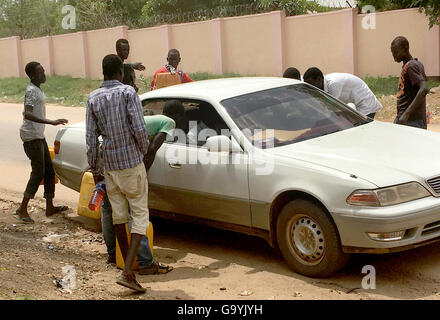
[266,121,440,187]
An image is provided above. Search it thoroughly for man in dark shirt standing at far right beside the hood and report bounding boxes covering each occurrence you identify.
[391,37,429,129]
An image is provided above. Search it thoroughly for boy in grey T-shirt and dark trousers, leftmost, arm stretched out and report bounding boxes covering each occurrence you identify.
[14,62,68,223]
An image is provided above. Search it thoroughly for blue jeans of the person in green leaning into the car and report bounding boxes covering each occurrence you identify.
[101,194,153,269]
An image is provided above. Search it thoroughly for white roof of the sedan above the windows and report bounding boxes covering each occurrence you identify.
[140,77,302,102]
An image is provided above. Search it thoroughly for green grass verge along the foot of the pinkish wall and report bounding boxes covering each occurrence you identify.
[0,72,440,107]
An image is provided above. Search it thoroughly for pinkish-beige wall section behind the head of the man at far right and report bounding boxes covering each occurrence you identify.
[357,9,432,77]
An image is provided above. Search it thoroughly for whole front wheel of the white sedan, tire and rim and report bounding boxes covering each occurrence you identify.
[277,199,350,278]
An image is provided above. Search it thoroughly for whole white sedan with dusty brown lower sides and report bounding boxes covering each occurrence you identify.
[54,78,440,277]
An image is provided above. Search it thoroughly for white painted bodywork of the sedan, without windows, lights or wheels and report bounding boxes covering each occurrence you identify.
[54,78,440,252]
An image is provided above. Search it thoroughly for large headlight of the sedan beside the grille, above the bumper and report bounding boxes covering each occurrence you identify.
[347,182,431,207]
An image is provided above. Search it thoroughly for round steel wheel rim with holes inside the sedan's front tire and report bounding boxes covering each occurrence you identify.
[290,216,325,265]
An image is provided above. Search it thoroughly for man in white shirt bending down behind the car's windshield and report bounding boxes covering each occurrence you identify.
[304,67,383,119]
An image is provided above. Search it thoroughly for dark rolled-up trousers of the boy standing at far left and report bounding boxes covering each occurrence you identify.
[23,139,55,199]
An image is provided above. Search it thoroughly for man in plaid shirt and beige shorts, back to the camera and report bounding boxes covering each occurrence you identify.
[86,54,149,293]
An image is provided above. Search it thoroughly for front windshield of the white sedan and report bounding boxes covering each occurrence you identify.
[221,84,372,149]
